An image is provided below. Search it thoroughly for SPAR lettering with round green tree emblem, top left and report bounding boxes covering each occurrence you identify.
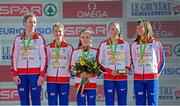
[0,3,57,17]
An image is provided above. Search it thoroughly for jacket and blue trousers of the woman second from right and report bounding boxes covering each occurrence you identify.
[97,38,131,105]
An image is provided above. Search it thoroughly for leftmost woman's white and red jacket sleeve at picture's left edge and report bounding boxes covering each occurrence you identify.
[11,36,19,76]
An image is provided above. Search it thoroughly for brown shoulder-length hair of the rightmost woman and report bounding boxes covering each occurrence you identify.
[134,19,154,41]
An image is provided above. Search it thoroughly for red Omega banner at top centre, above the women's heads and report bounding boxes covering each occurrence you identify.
[63,0,122,18]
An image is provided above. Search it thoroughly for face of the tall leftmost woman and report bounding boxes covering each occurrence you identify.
[24,17,36,31]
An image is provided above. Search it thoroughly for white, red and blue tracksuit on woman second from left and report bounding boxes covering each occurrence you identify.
[46,39,73,105]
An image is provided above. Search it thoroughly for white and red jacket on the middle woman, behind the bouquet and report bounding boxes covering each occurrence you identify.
[71,48,97,89]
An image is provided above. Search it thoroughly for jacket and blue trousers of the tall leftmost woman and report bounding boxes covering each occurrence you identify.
[12,33,46,105]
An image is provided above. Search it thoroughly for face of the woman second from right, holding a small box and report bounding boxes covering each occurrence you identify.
[109,24,120,39]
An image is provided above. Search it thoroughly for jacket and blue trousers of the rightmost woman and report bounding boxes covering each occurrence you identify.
[131,39,165,105]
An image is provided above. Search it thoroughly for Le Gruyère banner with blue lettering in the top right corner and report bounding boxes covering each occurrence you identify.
[127,0,180,17]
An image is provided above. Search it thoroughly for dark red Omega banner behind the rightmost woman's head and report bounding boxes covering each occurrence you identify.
[127,21,180,38]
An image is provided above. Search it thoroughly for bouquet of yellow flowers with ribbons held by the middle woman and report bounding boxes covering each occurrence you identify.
[72,57,100,94]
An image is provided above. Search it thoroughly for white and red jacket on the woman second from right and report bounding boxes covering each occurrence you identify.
[97,38,131,81]
